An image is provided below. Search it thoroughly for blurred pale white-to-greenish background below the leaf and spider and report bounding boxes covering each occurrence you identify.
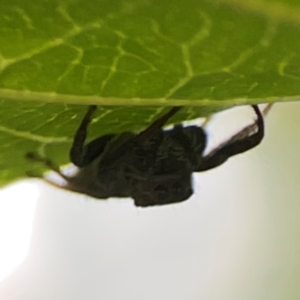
[0,103,300,300]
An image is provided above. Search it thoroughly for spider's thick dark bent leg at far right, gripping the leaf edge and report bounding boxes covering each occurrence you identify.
[194,105,264,172]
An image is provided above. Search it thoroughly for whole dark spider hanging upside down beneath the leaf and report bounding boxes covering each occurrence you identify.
[27,105,264,207]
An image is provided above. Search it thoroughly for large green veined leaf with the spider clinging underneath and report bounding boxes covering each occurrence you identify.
[0,0,300,185]
